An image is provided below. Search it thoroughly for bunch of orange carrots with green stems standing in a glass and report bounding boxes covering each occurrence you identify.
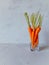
[25,11,42,48]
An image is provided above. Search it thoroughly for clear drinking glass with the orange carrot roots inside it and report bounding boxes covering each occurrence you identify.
[28,27,41,51]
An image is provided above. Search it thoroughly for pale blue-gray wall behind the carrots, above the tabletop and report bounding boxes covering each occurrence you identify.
[0,0,49,44]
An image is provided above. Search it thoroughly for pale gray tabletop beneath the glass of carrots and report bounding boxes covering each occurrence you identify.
[0,44,49,65]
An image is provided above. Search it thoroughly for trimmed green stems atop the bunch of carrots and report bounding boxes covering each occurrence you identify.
[24,11,42,28]
